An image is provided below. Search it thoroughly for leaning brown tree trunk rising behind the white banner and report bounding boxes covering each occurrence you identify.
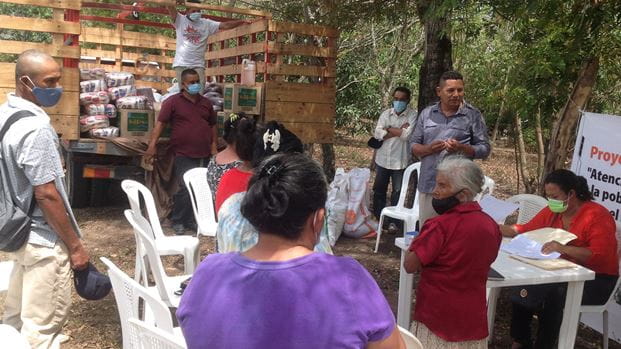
[540,57,599,190]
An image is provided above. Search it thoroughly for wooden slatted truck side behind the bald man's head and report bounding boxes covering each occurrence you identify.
[0,0,81,139]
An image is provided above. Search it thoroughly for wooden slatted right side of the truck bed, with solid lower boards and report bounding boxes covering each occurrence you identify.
[205,19,338,143]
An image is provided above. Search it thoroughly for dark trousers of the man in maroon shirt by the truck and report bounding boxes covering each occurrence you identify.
[170,156,209,228]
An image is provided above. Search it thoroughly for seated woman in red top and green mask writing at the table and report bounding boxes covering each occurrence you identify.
[500,170,619,349]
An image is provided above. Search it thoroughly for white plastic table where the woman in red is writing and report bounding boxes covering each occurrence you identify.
[395,238,595,348]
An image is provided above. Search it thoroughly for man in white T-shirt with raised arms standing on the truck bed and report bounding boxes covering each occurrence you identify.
[168,0,248,94]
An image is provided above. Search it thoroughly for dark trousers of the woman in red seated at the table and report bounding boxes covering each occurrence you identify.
[511,274,617,349]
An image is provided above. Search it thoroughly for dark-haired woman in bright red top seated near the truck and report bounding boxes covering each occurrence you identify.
[215,115,257,213]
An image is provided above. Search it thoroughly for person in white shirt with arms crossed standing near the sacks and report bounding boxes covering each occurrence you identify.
[373,86,416,229]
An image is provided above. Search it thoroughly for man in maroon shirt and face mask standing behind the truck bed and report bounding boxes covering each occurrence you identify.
[145,69,217,234]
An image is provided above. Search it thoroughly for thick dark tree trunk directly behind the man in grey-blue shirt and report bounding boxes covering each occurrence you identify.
[417,0,453,113]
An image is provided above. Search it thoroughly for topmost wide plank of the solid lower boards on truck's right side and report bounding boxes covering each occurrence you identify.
[265,81,336,104]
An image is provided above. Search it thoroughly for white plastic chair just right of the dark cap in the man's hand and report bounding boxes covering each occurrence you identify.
[100,257,181,349]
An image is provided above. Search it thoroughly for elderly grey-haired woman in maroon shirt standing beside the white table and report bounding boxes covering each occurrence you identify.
[404,156,502,348]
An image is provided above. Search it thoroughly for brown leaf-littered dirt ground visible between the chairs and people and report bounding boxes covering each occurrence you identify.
[0,135,621,349]
